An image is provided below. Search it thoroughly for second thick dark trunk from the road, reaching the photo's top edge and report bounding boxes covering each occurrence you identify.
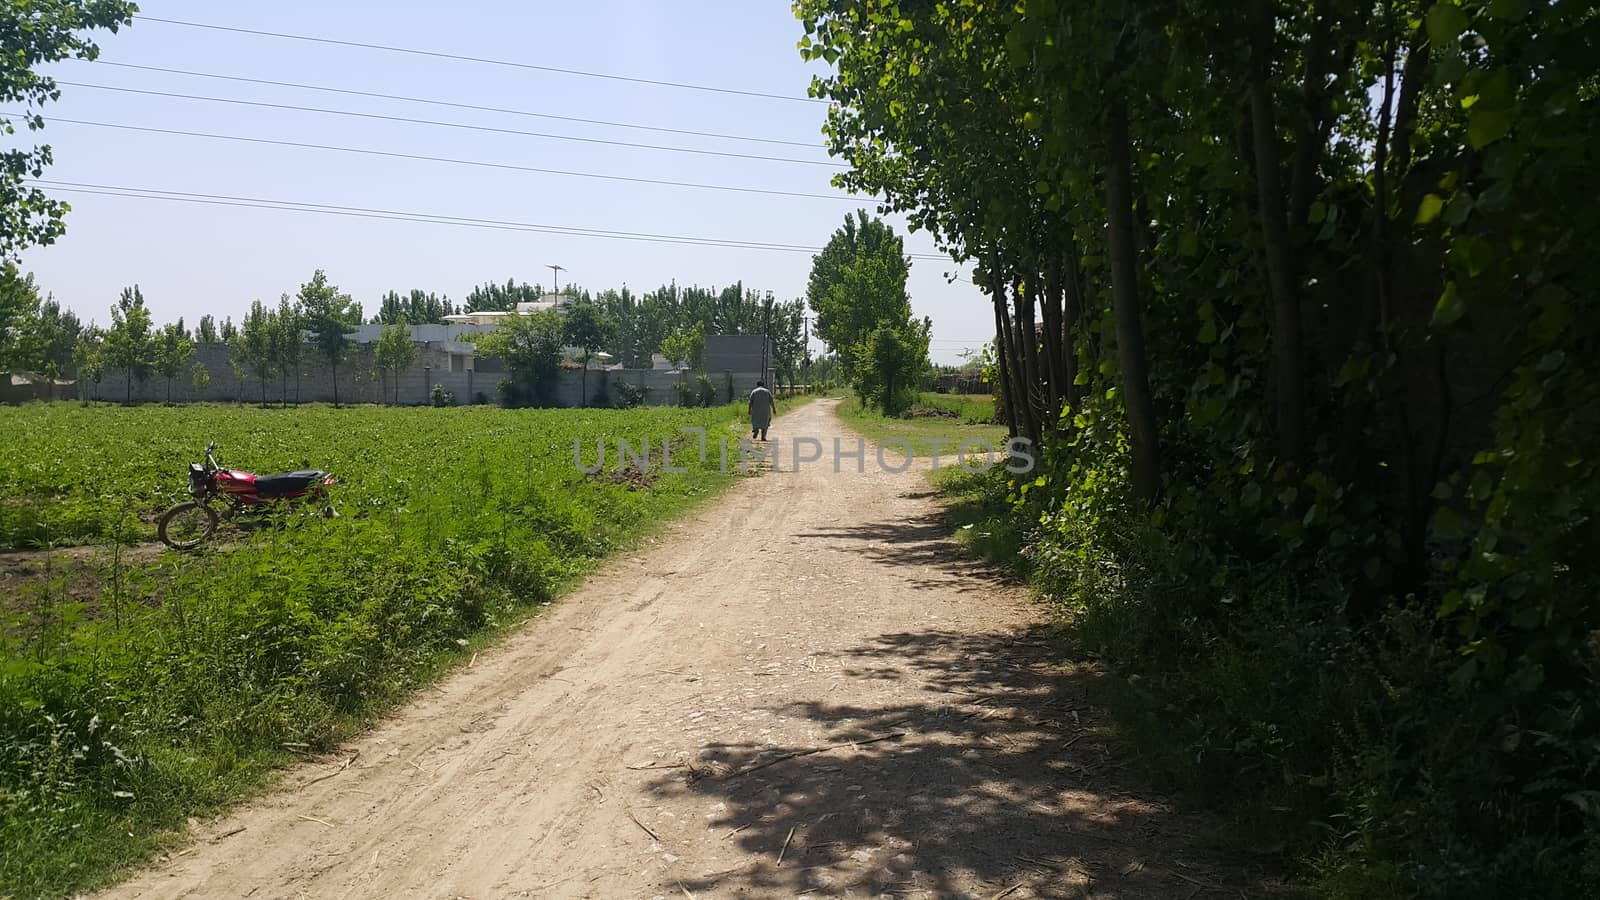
[1250,10,1306,464]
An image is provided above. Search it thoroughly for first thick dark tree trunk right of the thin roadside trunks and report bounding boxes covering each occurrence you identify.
[1106,96,1162,504]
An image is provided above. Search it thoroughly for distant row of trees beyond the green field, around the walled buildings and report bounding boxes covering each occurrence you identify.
[12,267,805,404]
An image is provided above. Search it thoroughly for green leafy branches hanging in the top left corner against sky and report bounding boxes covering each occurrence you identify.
[0,0,138,259]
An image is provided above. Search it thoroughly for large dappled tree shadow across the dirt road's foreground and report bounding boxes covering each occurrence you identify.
[650,626,1270,898]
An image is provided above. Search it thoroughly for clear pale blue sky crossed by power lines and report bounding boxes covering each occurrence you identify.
[15,0,994,362]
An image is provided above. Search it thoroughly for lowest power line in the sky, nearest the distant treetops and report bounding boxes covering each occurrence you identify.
[27,179,938,259]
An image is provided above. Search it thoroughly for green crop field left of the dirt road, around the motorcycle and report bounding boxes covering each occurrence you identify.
[0,404,768,897]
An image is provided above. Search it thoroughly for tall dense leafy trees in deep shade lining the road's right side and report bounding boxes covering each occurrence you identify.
[795,0,1600,897]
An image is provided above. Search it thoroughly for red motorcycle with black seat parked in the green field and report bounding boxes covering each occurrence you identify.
[157,442,334,549]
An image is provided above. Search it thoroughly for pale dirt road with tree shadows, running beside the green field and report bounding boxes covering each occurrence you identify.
[106,402,1262,900]
